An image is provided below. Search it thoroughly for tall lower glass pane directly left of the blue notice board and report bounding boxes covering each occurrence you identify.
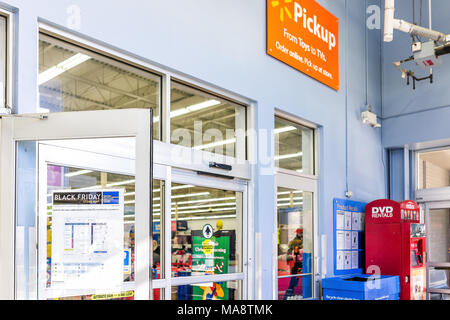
[277,187,313,300]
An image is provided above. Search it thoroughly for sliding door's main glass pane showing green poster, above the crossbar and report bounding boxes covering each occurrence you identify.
[168,183,242,277]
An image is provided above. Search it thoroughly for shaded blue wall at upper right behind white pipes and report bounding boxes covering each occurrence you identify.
[382,0,450,147]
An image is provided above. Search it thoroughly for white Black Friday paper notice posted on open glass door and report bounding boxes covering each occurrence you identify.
[50,190,124,290]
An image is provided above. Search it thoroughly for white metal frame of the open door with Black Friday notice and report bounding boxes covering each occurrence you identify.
[0,109,153,300]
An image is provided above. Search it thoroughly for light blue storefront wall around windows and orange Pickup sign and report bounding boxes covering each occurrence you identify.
[1,0,386,299]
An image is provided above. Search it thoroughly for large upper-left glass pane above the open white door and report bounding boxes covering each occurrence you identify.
[38,34,161,139]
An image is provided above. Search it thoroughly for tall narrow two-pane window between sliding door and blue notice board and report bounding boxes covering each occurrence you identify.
[274,115,318,300]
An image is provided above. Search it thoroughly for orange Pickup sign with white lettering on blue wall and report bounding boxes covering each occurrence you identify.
[267,0,339,90]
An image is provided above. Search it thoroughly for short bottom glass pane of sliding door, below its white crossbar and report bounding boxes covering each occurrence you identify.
[172,281,242,301]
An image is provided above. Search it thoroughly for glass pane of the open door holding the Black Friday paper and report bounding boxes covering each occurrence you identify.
[17,138,142,300]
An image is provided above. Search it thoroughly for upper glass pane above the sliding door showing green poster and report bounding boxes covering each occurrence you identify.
[170,81,246,160]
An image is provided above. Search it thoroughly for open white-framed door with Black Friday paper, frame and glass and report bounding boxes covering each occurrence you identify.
[0,109,152,299]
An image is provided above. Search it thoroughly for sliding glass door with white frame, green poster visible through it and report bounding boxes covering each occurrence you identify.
[166,170,247,300]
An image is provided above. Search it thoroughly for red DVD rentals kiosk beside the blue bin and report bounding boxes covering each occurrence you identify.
[365,200,426,300]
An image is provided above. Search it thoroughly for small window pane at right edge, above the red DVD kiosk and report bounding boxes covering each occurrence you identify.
[417,149,450,190]
